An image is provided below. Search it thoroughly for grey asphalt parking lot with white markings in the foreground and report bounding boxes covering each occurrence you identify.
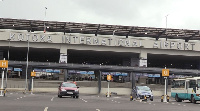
[0,92,200,111]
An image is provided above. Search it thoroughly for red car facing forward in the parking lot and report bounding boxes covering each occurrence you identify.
[58,82,79,98]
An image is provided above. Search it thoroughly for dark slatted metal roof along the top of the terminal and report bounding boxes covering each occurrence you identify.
[0,18,200,42]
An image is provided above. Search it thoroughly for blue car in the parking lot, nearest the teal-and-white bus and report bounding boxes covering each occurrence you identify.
[136,86,153,101]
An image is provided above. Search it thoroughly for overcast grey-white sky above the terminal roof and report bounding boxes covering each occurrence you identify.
[0,0,200,30]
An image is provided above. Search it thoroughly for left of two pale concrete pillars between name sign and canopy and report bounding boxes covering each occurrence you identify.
[59,47,67,63]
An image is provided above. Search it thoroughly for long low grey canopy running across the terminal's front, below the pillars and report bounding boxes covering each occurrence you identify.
[9,61,200,75]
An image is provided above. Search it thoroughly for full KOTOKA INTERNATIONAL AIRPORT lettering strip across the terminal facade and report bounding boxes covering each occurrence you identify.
[9,33,195,50]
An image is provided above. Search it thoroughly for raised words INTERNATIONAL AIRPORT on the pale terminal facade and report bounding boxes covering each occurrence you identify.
[62,36,195,50]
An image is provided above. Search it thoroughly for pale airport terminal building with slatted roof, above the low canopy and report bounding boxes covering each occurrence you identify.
[0,18,200,83]
